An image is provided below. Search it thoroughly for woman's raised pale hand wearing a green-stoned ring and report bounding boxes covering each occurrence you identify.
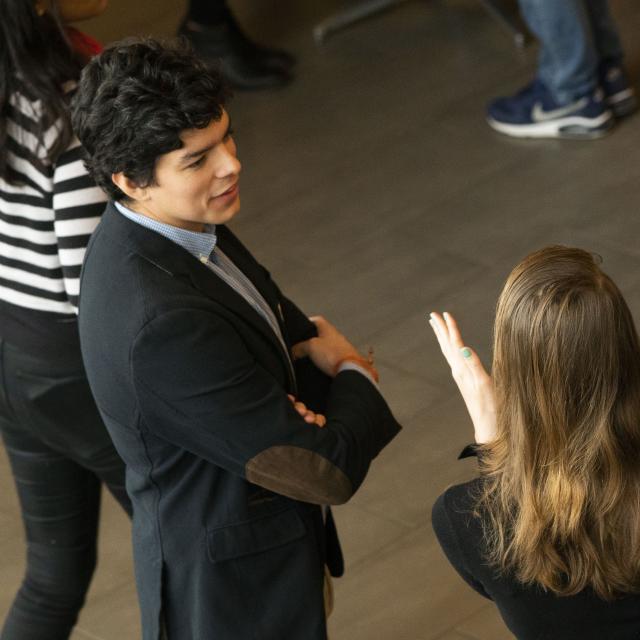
[429,313,496,444]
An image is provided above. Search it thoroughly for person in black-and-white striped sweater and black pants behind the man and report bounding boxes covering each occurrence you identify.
[0,0,131,640]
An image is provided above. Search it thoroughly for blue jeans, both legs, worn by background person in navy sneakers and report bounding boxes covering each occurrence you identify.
[519,0,623,104]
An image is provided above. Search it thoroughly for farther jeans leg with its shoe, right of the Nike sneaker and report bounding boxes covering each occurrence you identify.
[585,0,638,118]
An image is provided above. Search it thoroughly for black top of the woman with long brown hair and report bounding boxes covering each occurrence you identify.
[431,478,640,640]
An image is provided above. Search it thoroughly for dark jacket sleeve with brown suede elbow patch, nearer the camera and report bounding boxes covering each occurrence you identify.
[130,309,400,504]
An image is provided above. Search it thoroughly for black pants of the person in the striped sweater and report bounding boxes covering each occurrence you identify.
[0,339,131,640]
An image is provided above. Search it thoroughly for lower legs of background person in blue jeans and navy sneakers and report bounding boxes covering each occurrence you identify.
[488,0,637,139]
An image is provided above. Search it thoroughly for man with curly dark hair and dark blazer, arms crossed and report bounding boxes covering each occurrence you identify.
[73,40,399,640]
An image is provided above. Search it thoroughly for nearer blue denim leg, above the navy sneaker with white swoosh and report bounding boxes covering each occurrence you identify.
[519,0,606,104]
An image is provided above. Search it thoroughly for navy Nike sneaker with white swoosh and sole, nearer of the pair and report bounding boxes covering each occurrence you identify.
[487,79,614,139]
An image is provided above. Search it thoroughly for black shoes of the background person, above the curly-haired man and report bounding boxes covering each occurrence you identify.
[178,20,292,90]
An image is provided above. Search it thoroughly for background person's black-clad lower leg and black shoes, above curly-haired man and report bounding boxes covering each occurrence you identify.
[179,0,295,90]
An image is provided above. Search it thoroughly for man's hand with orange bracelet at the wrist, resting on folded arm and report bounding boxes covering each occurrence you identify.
[292,316,378,380]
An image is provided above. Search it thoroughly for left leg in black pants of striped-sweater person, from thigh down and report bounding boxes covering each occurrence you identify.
[0,425,100,640]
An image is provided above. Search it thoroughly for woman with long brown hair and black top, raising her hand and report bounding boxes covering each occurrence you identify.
[430,247,640,640]
